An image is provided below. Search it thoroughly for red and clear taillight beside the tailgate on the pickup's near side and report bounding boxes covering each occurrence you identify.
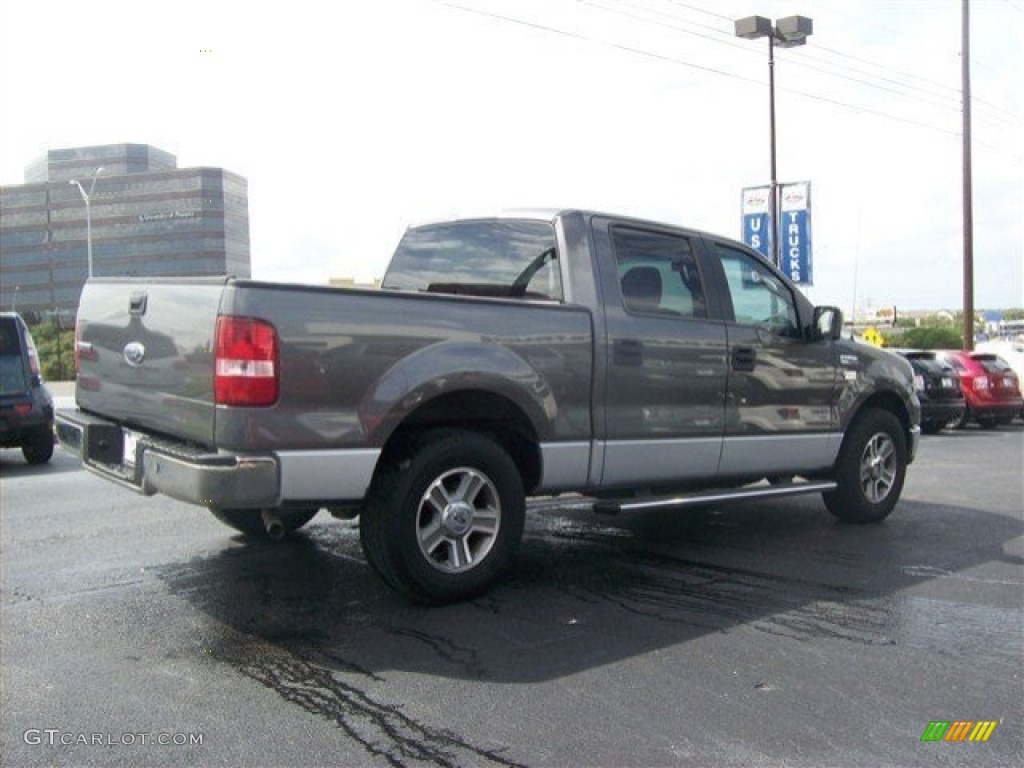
[213,315,279,406]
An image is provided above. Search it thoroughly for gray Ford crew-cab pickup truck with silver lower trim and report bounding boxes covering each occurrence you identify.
[57,210,920,602]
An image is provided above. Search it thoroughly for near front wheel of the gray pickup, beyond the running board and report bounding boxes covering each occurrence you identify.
[822,409,906,523]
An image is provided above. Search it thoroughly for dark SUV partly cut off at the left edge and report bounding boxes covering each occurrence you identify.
[0,312,53,464]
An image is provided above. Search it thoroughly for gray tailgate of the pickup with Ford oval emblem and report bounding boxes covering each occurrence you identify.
[77,278,227,445]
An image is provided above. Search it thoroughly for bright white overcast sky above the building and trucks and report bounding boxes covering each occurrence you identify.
[0,0,1024,309]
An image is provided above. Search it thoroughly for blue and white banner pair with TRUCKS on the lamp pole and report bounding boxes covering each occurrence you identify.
[742,181,814,285]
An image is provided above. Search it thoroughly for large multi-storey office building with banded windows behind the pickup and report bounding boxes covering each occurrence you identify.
[0,144,251,314]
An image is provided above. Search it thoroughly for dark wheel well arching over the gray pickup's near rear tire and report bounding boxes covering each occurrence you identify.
[382,390,541,494]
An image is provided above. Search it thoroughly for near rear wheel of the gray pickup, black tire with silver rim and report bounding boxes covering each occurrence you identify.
[359,430,526,603]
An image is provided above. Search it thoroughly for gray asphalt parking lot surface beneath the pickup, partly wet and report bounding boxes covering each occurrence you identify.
[0,422,1024,766]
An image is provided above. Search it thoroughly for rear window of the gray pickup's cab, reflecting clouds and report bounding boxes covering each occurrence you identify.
[382,219,563,301]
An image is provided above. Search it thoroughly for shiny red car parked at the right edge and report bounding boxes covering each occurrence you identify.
[942,351,1024,428]
